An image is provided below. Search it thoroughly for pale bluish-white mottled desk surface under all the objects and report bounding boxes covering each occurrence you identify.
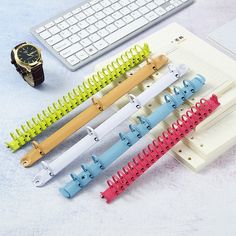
[0,0,236,236]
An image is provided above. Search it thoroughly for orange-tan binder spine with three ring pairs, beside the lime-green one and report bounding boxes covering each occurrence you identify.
[21,55,168,167]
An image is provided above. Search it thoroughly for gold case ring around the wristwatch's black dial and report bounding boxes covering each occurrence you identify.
[13,43,43,72]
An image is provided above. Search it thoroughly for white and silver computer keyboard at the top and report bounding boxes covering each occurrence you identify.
[31,0,194,71]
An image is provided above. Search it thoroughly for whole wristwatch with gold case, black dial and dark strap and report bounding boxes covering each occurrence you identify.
[11,42,44,87]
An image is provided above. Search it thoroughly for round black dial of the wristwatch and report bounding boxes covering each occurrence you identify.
[17,45,40,64]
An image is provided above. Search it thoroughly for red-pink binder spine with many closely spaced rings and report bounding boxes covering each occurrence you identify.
[101,95,220,203]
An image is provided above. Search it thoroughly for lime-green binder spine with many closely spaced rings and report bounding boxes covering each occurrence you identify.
[6,44,150,151]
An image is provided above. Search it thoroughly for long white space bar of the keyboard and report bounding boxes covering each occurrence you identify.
[105,17,148,44]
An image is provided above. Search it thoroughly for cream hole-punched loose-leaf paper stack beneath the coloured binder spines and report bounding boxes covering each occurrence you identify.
[98,23,236,171]
